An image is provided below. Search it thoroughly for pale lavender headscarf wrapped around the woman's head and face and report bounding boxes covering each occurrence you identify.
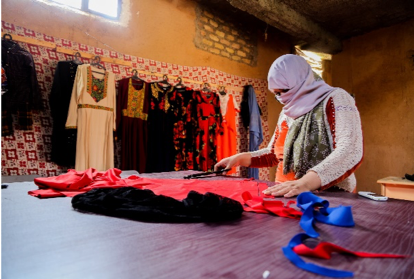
[267,54,334,119]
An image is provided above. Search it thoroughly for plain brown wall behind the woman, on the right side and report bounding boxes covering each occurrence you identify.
[332,20,414,193]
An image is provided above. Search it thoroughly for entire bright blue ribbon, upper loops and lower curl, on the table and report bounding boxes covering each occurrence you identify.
[282,192,355,278]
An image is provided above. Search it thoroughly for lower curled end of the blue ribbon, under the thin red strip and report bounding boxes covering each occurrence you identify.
[282,233,354,278]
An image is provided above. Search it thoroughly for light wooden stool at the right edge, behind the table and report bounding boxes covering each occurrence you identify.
[377,176,414,201]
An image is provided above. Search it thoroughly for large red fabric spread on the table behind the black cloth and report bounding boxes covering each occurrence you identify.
[29,168,267,206]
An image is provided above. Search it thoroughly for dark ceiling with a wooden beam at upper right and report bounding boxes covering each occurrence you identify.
[198,0,414,54]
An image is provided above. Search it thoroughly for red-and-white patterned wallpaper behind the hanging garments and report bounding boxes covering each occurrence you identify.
[1,21,270,180]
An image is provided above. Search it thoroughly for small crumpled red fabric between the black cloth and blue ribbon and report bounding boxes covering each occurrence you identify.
[242,192,302,219]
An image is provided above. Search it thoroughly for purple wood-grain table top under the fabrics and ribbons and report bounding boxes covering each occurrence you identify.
[1,171,414,279]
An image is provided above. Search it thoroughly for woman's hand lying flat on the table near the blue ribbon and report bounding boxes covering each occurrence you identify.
[263,171,321,198]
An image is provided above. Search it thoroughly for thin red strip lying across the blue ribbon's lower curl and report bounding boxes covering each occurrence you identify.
[293,242,410,260]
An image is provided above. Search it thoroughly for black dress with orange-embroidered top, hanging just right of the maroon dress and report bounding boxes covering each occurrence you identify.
[146,82,175,172]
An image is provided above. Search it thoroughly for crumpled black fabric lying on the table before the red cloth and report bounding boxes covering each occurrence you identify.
[72,187,243,223]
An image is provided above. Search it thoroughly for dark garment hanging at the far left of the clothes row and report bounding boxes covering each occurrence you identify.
[1,39,43,136]
